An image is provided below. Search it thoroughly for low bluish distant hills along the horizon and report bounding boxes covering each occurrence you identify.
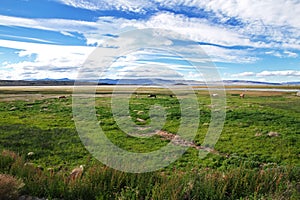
[0,78,300,86]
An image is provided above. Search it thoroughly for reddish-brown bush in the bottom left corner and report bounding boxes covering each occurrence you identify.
[0,174,24,200]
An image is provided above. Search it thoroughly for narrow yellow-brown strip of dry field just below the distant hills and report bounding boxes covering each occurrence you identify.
[0,85,295,101]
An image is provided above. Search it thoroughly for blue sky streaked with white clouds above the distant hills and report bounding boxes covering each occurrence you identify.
[0,0,300,82]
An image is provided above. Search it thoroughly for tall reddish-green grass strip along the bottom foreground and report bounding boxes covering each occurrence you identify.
[0,151,300,199]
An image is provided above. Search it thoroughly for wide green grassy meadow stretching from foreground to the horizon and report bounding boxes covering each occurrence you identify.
[0,87,300,199]
